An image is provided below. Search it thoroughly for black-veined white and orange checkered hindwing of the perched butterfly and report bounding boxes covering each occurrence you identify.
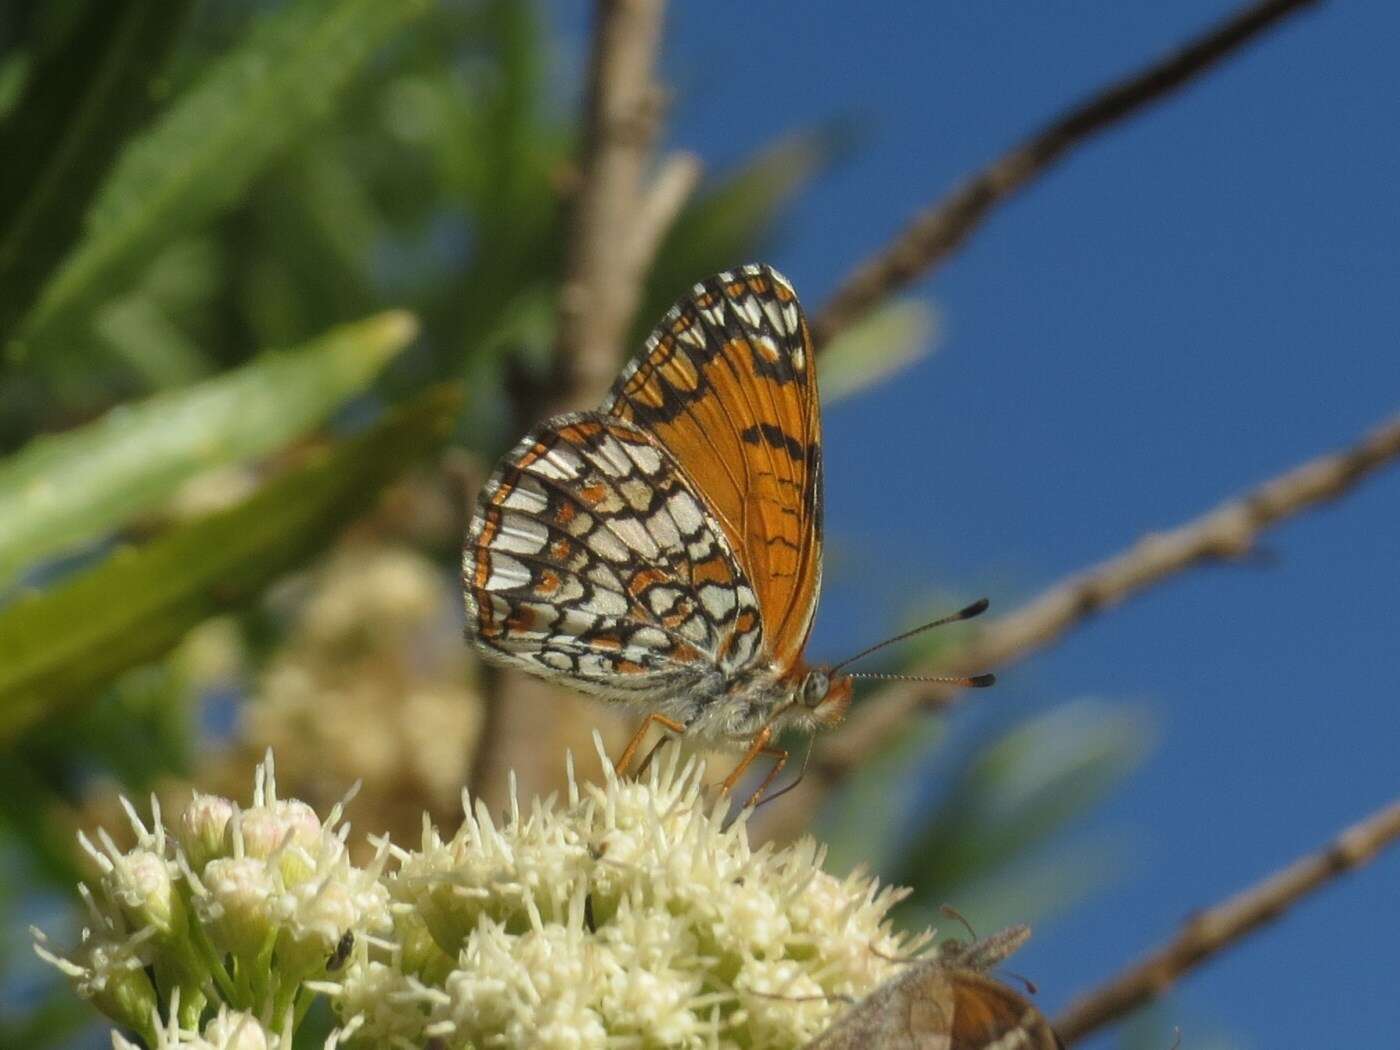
[462,413,763,700]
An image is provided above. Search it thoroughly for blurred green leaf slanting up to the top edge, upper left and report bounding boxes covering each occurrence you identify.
[20,0,428,358]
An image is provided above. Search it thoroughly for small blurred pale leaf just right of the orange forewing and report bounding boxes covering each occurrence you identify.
[822,300,938,405]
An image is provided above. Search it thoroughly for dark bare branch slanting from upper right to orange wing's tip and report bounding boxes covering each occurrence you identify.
[812,0,1317,346]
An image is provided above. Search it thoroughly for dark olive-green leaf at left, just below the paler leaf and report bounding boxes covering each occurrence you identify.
[0,388,461,743]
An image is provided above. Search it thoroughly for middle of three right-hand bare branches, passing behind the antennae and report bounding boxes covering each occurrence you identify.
[764,416,1400,836]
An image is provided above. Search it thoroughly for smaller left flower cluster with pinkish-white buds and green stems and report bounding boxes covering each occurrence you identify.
[35,755,392,1050]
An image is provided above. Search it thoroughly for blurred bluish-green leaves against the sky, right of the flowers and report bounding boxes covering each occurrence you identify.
[820,701,1149,928]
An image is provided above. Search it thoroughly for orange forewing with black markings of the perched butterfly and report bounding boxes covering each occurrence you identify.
[602,266,822,668]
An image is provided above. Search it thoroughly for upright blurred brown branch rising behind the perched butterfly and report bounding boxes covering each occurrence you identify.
[554,0,665,407]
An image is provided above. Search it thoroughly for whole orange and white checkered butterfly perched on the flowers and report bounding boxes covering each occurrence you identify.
[462,265,991,804]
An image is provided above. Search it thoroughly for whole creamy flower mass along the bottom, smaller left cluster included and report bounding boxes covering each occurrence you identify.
[39,748,928,1050]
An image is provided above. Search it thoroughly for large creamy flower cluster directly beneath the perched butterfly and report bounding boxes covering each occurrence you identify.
[318,749,927,1050]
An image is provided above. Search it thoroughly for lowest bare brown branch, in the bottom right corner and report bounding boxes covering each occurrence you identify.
[1054,801,1400,1043]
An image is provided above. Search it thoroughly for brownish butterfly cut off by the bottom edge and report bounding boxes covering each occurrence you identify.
[804,925,1064,1050]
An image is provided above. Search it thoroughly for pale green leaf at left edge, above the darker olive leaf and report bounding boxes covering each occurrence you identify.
[0,312,416,584]
